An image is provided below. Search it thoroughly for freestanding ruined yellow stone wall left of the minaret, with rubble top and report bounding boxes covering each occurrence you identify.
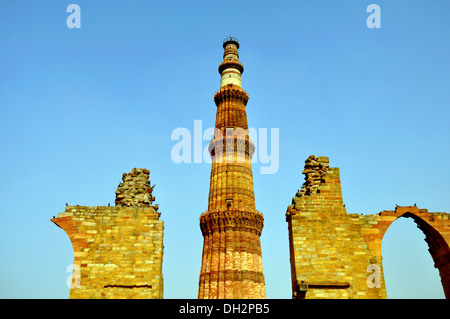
[51,169,164,299]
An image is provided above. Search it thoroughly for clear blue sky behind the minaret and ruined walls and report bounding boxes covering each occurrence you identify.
[0,0,450,298]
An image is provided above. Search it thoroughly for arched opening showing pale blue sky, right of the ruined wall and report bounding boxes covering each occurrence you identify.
[382,218,446,299]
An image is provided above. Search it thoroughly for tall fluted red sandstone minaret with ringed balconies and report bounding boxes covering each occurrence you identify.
[198,36,266,299]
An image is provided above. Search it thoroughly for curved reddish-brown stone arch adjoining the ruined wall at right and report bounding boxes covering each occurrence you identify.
[378,206,450,299]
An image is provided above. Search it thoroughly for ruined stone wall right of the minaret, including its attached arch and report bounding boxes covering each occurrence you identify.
[286,156,450,299]
